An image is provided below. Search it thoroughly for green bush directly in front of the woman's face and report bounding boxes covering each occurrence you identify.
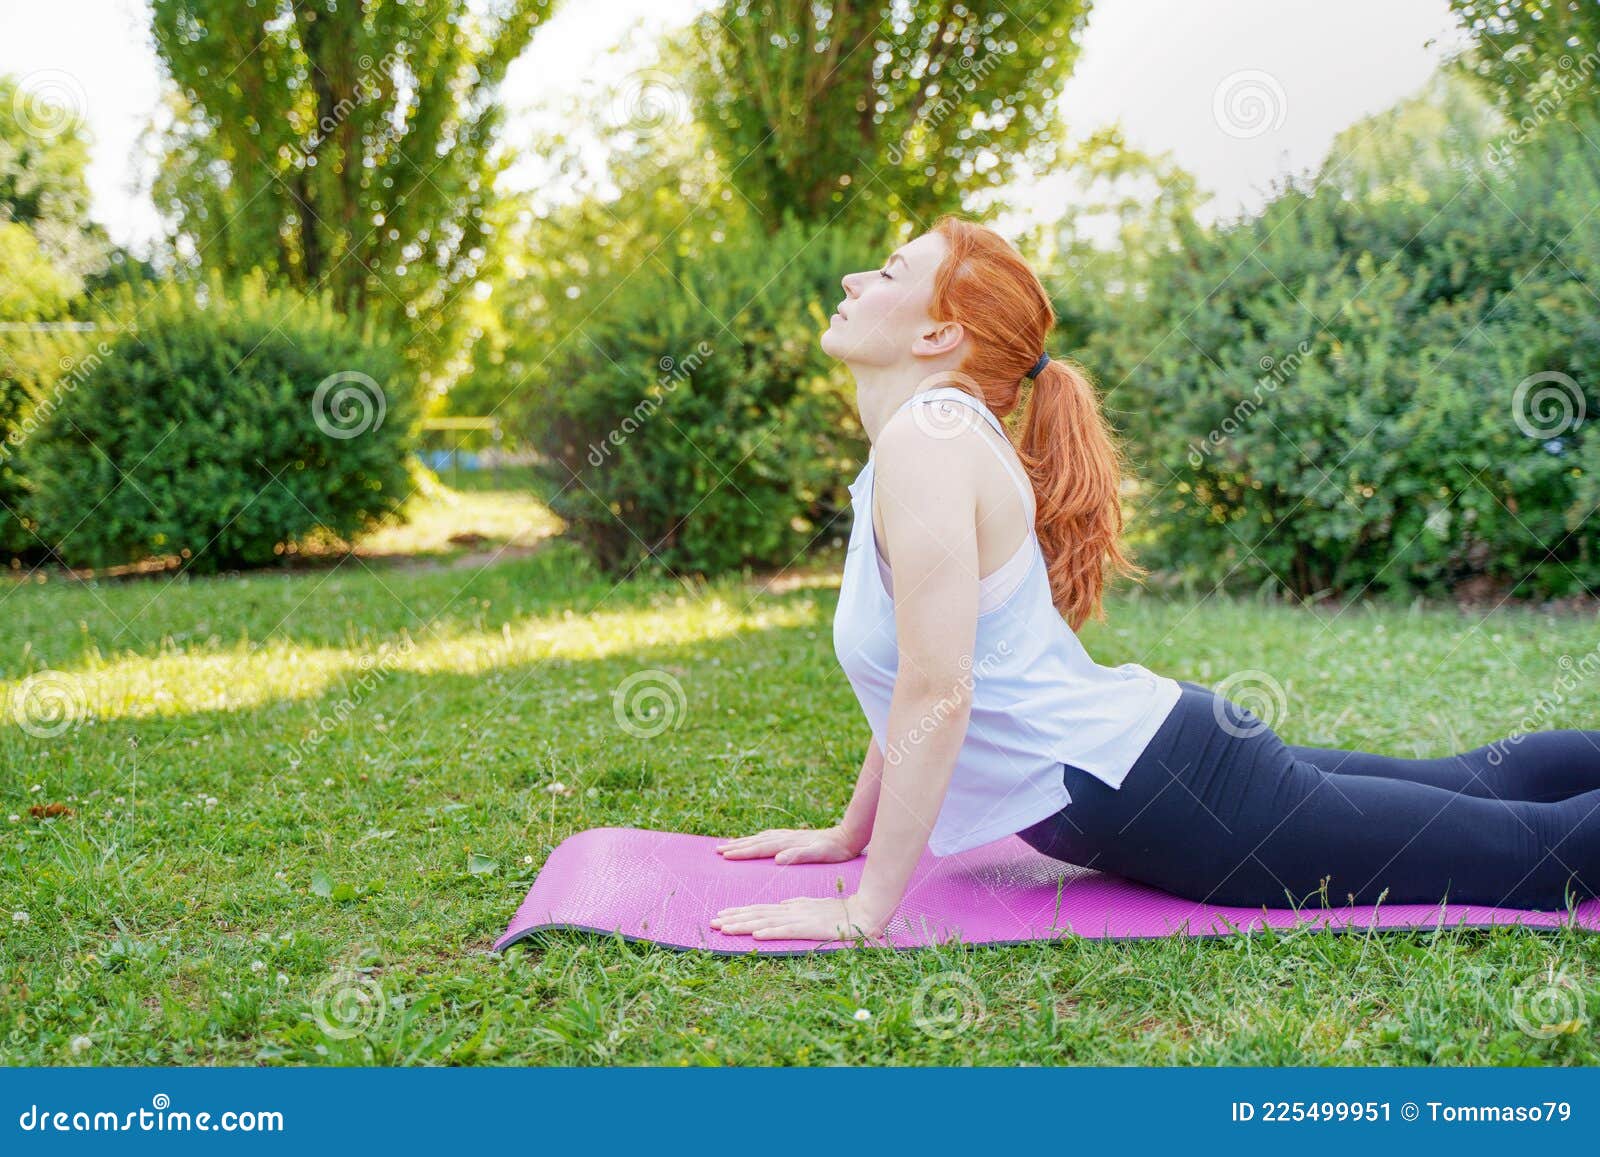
[477,206,882,574]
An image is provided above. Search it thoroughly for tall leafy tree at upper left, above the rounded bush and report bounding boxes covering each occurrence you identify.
[152,0,554,387]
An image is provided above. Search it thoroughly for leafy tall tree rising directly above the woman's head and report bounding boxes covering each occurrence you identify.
[685,0,1088,241]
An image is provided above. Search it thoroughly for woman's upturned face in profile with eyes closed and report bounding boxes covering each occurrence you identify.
[822,232,947,366]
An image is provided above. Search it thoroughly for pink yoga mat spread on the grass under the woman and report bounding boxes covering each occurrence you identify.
[494,827,1600,955]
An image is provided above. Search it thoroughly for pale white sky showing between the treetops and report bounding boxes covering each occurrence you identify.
[0,0,1462,254]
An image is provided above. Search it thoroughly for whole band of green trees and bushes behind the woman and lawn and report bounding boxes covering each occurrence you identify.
[0,0,1600,599]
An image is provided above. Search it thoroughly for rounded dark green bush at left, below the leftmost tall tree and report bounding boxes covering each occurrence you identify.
[24,277,418,571]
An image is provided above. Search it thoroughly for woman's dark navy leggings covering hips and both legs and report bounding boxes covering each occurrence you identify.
[1019,680,1600,911]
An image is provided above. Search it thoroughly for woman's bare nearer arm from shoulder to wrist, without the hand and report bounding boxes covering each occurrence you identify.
[853,422,978,933]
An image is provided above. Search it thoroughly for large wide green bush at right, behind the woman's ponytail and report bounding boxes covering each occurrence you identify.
[1083,86,1600,597]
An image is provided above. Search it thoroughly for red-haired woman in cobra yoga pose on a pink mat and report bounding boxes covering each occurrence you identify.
[710,218,1600,939]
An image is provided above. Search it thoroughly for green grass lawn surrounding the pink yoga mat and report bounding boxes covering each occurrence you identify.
[0,473,1600,1064]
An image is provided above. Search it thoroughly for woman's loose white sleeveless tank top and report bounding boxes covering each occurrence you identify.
[834,386,1182,856]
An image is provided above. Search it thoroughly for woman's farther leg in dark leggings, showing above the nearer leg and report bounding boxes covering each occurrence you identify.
[1288,730,1600,802]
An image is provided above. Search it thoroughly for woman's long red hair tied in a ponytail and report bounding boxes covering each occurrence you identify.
[933,216,1146,631]
